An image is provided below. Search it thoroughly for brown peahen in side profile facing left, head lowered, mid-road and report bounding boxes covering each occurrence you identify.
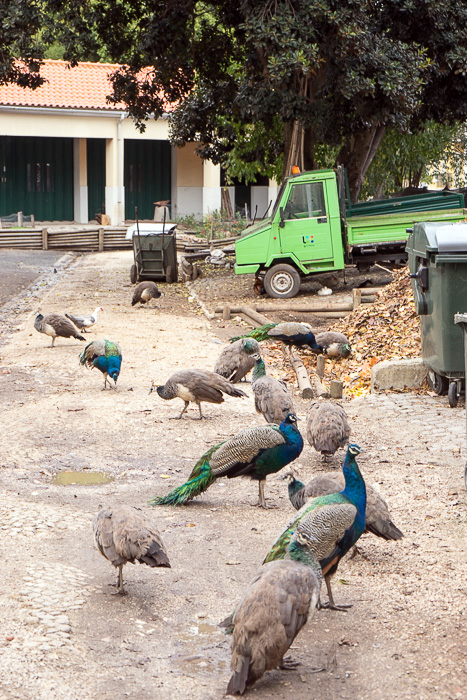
[154,369,246,419]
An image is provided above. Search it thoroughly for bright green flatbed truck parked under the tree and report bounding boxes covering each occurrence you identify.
[235,168,467,299]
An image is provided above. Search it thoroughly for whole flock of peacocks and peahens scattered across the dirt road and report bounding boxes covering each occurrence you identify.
[34,282,403,695]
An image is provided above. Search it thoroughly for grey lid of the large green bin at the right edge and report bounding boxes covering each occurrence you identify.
[412,221,467,254]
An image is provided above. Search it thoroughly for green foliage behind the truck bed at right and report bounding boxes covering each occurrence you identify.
[361,121,465,199]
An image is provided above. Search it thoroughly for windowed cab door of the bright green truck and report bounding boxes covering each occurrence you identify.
[279,182,333,262]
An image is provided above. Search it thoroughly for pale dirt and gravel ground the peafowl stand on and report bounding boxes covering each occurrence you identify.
[0,252,467,700]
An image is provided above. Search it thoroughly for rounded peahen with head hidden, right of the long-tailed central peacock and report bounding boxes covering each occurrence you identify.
[306,400,350,460]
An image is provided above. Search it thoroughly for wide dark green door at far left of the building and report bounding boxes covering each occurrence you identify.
[0,136,74,221]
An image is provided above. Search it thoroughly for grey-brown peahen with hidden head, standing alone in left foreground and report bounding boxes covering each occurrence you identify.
[92,506,170,594]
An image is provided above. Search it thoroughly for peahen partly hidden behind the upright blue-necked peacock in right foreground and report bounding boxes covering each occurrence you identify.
[289,472,404,540]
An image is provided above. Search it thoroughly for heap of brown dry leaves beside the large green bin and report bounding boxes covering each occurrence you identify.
[303,268,421,396]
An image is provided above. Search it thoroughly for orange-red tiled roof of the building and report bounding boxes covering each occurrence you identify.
[0,59,125,110]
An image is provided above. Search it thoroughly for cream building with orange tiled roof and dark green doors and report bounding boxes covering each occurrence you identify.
[0,59,276,225]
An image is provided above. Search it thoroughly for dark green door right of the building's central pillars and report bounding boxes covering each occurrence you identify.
[124,139,171,220]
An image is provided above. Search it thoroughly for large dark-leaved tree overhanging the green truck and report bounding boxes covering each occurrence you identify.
[2,0,467,200]
